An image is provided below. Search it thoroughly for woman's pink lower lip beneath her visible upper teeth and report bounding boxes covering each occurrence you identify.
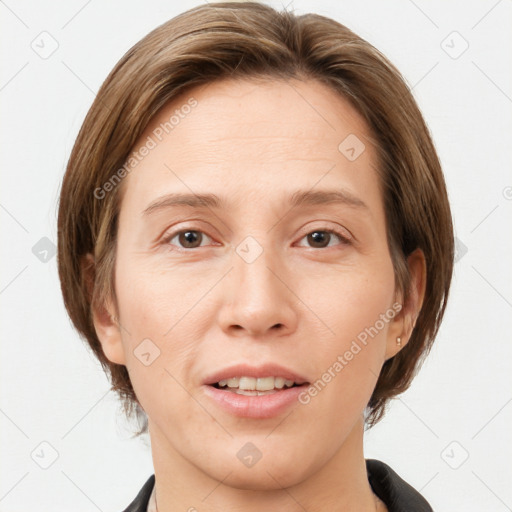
[203,385,307,419]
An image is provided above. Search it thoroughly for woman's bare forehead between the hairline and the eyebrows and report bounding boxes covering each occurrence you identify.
[116,79,377,212]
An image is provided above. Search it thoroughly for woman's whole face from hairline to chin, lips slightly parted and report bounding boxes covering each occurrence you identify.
[95,80,410,489]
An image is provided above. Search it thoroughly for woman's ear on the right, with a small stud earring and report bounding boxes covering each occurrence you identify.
[386,249,427,360]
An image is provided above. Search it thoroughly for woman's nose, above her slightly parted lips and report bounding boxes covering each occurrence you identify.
[219,238,299,338]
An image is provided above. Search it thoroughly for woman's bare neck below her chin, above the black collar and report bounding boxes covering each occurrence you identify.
[149,419,382,512]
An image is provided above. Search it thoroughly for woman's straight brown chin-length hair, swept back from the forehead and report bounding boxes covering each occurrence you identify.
[58,2,454,435]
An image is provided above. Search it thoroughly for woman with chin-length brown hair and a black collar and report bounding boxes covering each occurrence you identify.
[58,3,453,512]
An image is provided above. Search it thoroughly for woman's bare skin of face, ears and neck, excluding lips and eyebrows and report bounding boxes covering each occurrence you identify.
[93,79,425,512]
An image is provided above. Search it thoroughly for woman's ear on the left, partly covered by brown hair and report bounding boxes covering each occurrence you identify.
[81,253,126,365]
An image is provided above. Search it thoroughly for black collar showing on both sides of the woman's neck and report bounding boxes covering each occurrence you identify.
[123,459,433,512]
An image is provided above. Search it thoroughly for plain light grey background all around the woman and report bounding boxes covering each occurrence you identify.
[0,0,512,512]
